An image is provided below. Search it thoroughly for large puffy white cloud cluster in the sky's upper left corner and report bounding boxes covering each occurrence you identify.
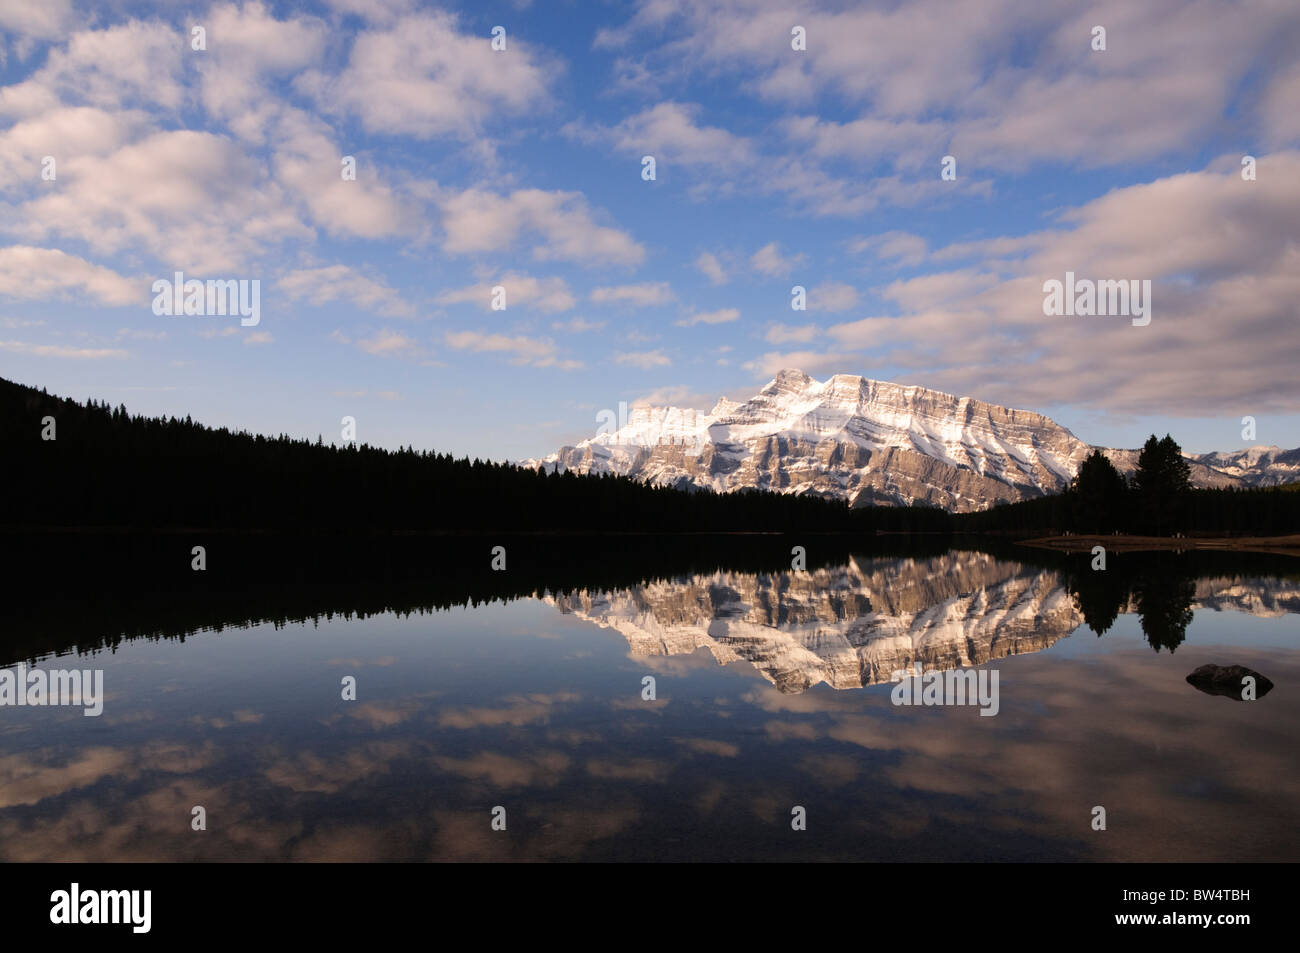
[0,1,416,284]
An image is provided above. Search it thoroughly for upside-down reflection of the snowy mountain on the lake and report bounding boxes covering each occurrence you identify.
[547,551,1300,693]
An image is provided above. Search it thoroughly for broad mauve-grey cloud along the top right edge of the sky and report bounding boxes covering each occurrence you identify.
[597,0,1300,171]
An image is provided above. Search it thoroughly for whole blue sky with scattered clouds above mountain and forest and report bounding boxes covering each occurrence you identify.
[0,0,1300,459]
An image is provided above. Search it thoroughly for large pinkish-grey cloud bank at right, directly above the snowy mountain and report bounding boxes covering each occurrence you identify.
[827,152,1300,417]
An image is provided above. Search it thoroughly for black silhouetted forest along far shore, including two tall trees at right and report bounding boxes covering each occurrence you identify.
[0,380,1300,536]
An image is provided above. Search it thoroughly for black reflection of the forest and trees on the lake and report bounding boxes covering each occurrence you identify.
[0,532,1300,667]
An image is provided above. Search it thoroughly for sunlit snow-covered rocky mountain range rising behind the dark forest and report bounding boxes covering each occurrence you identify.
[525,369,1300,512]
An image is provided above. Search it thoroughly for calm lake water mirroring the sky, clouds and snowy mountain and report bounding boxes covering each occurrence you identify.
[0,549,1300,861]
